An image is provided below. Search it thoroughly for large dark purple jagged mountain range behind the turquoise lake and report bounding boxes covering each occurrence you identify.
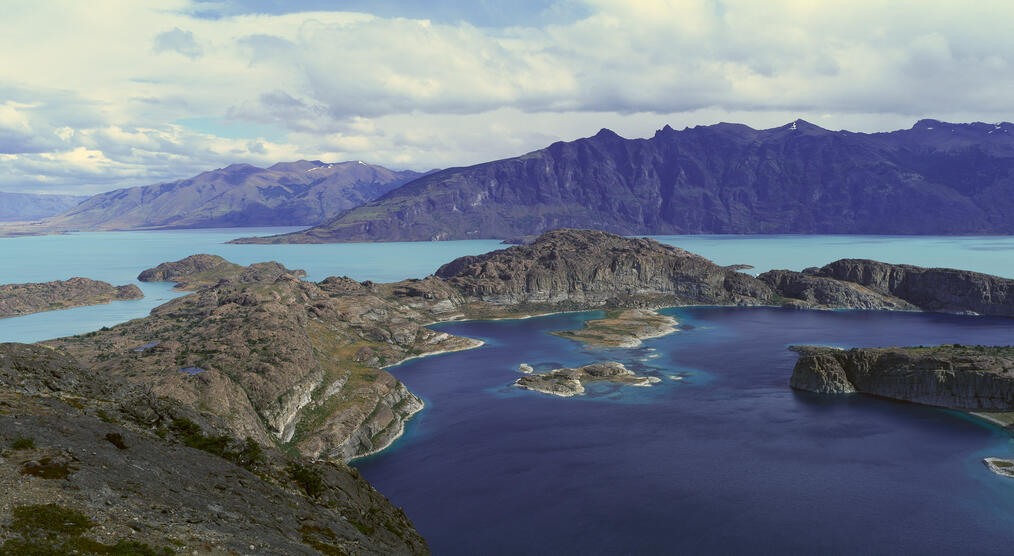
[233,120,1014,242]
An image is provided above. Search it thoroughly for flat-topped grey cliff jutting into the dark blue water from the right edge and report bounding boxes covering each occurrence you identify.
[789,346,1014,411]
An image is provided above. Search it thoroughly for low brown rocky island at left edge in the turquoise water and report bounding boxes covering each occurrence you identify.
[0,277,144,319]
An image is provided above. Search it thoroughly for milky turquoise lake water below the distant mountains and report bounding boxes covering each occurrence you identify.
[0,227,1014,342]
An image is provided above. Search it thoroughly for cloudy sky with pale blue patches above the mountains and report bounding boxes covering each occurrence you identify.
[0,0,1014,195]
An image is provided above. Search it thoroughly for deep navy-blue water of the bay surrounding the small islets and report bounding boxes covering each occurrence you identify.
[356,307,1014,554]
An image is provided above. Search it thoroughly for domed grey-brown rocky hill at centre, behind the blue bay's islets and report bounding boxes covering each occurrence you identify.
[436,229,772,308]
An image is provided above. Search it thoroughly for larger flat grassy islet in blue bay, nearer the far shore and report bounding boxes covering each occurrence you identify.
[551,308,679,348]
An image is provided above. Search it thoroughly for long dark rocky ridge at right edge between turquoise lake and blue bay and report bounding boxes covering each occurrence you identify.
[758,259,1014,317]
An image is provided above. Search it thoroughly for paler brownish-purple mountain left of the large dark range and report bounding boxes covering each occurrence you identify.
[20,160,423,231]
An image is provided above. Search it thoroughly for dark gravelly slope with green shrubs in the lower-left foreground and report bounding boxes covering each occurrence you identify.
[0,344,427,555]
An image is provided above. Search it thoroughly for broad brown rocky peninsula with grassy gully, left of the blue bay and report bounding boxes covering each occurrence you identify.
[50,256,480,461]
